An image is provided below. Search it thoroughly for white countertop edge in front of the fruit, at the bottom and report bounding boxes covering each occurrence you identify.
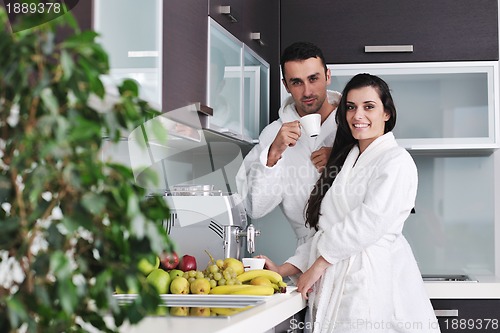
[120,287,306,333]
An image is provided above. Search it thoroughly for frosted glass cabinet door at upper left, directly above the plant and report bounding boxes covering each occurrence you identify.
[94,0,162,105]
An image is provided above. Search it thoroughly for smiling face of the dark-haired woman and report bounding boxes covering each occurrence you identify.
[346,86,390,152]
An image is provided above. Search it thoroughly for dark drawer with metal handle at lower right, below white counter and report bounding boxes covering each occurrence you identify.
[431,299,500,333]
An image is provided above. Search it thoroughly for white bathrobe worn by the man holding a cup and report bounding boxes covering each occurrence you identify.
[236,91,340,244]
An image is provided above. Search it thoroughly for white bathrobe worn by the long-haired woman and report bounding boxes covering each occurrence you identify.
[288,132,439,333]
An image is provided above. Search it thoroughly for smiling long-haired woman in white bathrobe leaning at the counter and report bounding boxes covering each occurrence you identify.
[260,74,439,333]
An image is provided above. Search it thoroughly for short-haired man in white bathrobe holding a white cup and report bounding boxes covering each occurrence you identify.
[236,42,340,245]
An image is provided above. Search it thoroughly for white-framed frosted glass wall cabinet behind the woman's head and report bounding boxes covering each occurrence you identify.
[322,62,499,150]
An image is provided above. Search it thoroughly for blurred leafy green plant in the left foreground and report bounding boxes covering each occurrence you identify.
[0,7,173,333]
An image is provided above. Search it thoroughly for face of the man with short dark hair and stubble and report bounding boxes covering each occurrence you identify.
[283,58,330,117]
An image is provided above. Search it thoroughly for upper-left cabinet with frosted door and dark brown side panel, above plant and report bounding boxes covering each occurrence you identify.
[94,0,208,111]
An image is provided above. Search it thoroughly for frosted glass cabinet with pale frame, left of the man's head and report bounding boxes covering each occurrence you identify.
[208,19,269,142]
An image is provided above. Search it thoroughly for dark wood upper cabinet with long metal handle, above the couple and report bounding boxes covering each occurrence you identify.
[281,0,498,64]
